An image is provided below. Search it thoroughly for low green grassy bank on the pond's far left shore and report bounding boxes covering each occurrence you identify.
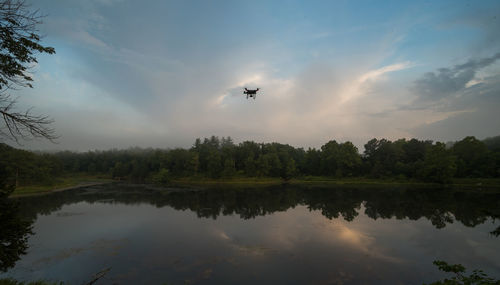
[10,174,113,197]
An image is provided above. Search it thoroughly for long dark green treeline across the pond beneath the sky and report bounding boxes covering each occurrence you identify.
[0,136,500,189]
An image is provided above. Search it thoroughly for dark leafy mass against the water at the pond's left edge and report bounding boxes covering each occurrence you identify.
[0,193,32,272]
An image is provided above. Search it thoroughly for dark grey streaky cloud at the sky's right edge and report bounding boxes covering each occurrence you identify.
[412,53,500,101]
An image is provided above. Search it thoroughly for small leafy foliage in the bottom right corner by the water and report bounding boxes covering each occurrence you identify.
[430,260,500,285]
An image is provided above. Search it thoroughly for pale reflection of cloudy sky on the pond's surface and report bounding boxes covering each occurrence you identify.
[0,202,500,284]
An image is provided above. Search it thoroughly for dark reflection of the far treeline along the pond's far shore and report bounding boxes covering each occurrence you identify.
[13,184,500,232]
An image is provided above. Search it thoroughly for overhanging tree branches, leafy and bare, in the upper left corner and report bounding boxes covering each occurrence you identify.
[0,0,57,142]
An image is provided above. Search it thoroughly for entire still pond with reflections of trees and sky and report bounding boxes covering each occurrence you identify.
[0,184,500,284]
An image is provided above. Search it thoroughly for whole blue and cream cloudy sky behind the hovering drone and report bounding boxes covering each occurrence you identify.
[6,0,500,151]
